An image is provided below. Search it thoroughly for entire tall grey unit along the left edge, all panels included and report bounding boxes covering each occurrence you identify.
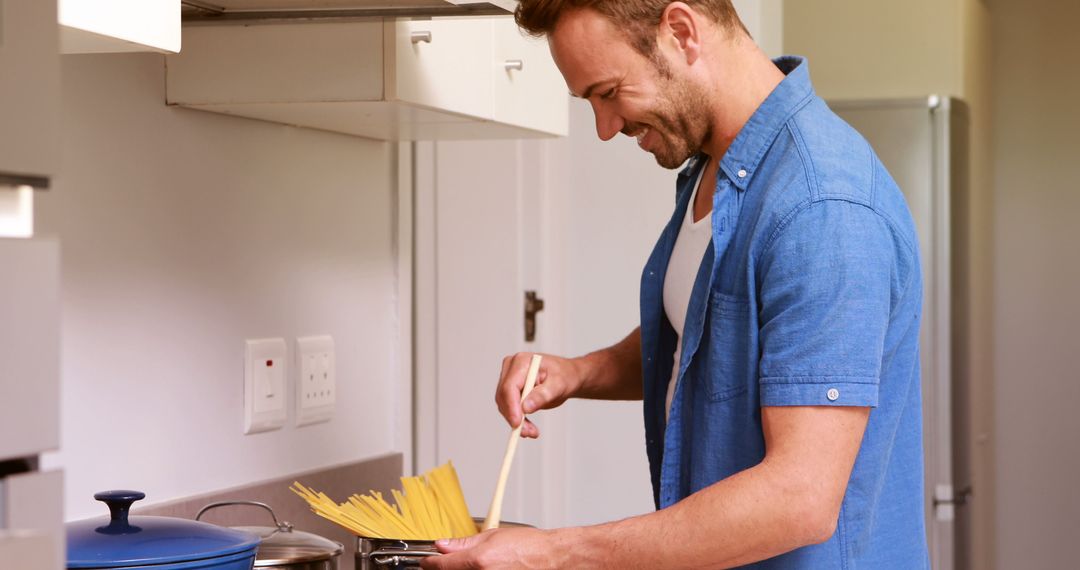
[0,0,65,570]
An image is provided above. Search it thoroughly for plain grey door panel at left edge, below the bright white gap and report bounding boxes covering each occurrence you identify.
[0,238,60,460]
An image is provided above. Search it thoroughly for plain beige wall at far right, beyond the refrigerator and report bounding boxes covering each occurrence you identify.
[993,0,1080,569]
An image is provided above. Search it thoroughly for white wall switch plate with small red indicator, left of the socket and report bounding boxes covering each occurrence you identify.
[244,339,288,434]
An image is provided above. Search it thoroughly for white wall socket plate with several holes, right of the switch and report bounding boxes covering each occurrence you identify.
[296,336,337,425]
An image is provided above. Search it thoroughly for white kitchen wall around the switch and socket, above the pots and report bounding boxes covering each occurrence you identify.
[38,55,409,519]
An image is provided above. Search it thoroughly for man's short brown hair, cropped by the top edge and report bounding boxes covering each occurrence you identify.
[514,0,750,56]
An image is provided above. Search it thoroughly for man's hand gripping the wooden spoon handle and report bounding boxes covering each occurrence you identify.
[495,352,582,437]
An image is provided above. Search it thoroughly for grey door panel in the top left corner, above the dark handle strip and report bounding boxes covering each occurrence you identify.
[0,0,60,178]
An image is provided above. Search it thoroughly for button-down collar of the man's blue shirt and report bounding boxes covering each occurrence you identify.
[679,56,814,190]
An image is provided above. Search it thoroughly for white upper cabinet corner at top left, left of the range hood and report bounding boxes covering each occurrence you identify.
[58,0,180,54]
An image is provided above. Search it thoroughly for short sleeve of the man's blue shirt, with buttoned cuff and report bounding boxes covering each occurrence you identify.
[758,200,897,407]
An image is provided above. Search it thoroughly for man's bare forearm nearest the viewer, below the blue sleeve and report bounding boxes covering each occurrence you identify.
[552,406,870,568]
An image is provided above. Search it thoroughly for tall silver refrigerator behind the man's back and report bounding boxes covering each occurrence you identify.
[829,95,977,570]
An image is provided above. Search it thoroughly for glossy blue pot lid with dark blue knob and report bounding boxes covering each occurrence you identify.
[66,491,259,568]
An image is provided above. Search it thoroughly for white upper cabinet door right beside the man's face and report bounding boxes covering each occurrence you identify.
[492,17,569,136]
